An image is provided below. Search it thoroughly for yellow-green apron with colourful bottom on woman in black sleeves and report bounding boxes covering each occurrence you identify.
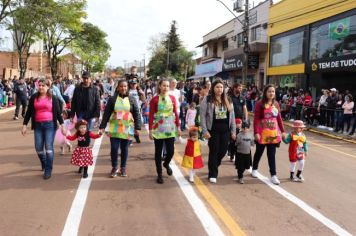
[109,97,134,139]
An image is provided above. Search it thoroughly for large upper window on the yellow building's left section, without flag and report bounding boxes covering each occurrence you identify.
[270,30,304,66]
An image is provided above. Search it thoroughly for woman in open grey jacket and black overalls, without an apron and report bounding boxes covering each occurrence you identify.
[200,79,236,183]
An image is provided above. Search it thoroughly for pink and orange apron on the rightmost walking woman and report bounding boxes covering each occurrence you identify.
[257,104,281,144]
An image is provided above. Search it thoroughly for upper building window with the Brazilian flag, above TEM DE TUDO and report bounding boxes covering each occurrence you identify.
[309,15,356,60]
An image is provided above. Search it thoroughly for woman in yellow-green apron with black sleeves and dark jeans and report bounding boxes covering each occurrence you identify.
[99,80,141,178]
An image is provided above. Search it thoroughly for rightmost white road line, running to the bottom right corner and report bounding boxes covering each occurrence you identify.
[250,170,352,236]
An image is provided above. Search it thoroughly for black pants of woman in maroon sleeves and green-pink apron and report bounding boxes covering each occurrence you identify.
[154,138,174,176]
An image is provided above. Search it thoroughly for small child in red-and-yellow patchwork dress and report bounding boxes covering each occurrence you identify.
[180,127,204,183]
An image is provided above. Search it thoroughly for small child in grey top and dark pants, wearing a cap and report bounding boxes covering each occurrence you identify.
[235,121,255,184]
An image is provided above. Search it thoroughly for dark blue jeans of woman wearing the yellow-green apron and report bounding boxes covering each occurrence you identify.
[110,138,130,168]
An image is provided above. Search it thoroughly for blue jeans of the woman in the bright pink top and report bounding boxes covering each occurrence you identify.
[34,121,55,176]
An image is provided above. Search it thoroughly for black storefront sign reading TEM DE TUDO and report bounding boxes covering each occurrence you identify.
[307,54,356,73]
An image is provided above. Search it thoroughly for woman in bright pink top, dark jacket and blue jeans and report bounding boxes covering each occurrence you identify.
[22,79,64,179]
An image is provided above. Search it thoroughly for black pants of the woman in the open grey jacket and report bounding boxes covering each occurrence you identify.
[208,132,230,178]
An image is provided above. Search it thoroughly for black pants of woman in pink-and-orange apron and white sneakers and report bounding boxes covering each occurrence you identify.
[252,142,277,176]
